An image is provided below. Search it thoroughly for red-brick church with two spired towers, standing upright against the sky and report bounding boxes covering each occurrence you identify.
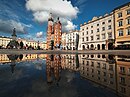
[47,14,62,50]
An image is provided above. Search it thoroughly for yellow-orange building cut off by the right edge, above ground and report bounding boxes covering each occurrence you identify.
[113,2,130,49]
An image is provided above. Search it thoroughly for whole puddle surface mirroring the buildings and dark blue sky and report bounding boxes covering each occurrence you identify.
[0,54,130,97]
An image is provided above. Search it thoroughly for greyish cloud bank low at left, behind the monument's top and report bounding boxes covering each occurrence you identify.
[0,19,31,34]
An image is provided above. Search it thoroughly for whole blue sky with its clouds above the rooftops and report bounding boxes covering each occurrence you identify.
[0,0,130,41]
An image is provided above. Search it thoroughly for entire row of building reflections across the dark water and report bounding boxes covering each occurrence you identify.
[0,54,130,97]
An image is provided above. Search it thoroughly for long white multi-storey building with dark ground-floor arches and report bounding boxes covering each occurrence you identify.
[79,13,114,50]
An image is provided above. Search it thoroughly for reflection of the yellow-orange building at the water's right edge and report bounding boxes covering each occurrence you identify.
[116,56,130,97]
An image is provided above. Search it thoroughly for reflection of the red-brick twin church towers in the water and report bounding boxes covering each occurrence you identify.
[46,55,61,85]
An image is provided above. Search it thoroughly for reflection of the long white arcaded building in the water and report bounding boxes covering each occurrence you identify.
[80,54,116,90]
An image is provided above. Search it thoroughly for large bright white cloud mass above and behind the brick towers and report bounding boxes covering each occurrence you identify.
[26,0,79,31]
